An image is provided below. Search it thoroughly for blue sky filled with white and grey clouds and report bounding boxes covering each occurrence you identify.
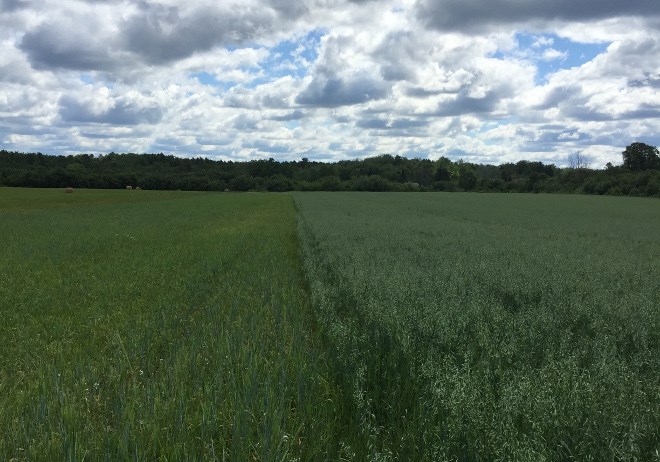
[0,0,660,168]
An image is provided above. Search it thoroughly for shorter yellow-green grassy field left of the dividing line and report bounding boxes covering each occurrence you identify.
[0,189,342,461]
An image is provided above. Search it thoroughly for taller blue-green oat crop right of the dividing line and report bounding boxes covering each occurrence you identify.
[294,193,660,461]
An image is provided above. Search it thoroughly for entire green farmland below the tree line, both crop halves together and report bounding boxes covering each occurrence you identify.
[0,188,660,461]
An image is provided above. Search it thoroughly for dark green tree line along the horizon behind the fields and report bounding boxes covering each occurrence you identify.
[0,143,660,197]
